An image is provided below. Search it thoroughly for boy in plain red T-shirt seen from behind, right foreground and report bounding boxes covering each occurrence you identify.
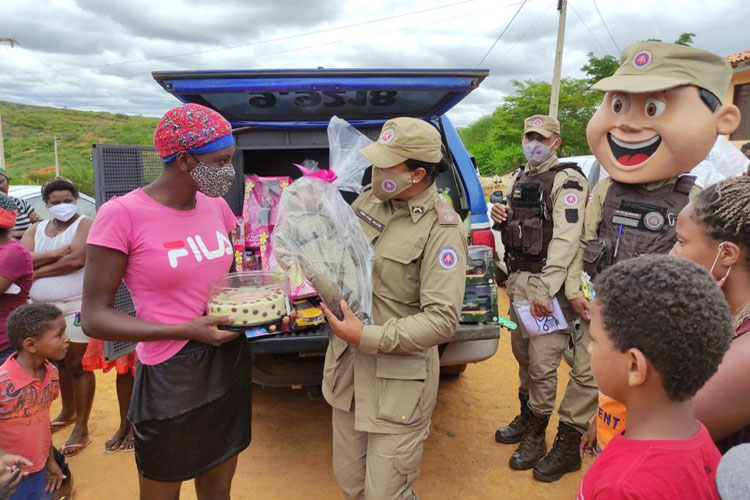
[578,255,734,500]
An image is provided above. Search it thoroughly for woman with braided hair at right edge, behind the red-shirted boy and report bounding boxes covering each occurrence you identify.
[671,176,750,453]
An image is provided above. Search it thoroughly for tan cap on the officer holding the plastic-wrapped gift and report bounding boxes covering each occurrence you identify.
[360,117,443,168]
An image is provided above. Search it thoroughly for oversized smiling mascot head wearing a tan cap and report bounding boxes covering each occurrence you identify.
[586,42,740,184]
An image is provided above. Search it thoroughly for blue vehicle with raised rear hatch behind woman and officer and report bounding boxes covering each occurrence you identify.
[92,69,500,388]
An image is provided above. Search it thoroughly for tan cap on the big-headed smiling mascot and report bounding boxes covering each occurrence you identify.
[592,42,732,101]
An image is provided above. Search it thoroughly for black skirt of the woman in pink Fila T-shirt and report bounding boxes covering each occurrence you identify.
[128,336,252,482]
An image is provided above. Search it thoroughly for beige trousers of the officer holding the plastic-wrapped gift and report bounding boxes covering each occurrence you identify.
[332,408,430,500]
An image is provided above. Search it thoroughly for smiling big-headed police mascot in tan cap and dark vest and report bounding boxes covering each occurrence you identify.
[565,42,740,468]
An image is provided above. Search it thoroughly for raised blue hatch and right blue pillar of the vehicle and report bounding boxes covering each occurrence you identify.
[153,69,489,226]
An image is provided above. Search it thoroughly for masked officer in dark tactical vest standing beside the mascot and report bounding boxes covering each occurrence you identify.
[492,115,597,481]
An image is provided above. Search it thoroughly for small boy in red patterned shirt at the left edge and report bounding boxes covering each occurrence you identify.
[0,304,68,500]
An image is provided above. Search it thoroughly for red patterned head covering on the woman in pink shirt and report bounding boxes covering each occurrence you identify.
[154,103,234,163]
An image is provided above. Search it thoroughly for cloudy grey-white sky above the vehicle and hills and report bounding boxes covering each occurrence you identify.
[0,0,750,126]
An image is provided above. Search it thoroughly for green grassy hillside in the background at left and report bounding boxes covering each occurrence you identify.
[0,101,158,195]
